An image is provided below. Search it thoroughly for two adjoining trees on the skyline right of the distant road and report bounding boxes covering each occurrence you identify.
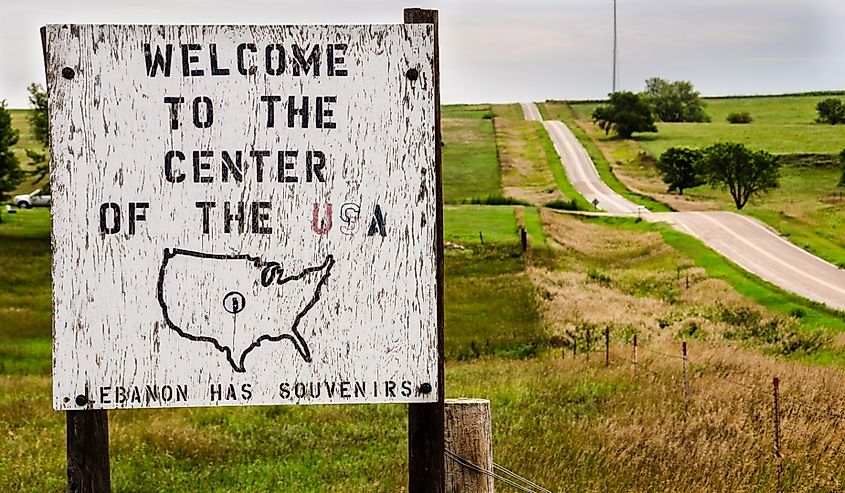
[592,77,710,139]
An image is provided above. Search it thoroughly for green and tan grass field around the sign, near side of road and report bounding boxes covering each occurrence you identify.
[0,97,845,492]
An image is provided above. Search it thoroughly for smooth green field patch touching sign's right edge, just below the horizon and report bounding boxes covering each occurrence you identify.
[442,105,502,203]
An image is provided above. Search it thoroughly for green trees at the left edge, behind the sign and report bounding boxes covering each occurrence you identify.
[0,83,50,219]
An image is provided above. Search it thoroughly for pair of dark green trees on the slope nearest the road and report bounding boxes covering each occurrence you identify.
[657,142,780,209]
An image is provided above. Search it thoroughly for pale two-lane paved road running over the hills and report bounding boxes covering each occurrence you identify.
[521,103,845,310]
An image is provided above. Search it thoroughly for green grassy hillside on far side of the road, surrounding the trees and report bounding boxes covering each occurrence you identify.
[573,96,845,266]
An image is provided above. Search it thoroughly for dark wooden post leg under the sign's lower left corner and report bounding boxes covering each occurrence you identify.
[66,408,111,493]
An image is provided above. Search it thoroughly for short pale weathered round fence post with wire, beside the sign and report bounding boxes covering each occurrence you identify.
[446,399,493,493]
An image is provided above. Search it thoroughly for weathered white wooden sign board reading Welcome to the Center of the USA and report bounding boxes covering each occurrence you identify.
[44,24,440,410]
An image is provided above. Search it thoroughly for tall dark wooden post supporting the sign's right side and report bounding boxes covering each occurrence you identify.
[404,8,446,493]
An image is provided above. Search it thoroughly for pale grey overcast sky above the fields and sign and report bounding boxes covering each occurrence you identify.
[0,0,845,108]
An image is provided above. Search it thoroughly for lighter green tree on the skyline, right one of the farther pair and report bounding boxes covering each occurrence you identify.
[643,77,710,122]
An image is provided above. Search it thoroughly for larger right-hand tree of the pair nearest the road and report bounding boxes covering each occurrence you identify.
[701,142,780,209]
